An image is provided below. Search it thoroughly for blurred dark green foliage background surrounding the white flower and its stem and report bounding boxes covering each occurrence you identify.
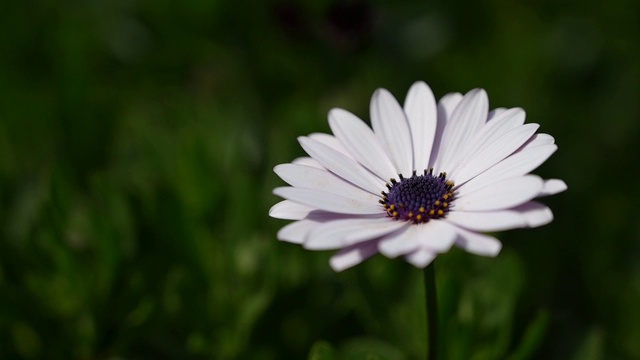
[0,0,640,360]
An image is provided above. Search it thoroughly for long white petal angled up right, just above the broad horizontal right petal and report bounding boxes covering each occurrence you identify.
[464,144,558,192]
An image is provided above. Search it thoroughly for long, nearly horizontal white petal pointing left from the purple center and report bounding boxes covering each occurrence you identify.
[273,187,384,215]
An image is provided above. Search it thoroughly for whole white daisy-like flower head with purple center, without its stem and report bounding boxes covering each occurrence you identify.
[269,82,567,271]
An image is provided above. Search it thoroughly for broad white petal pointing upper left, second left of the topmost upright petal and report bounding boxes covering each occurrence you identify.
[329,109,397,181]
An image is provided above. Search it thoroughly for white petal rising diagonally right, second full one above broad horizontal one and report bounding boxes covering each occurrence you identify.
[451,124,539,183]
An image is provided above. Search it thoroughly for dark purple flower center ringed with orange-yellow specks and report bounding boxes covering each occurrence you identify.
[380,169,454,224]
